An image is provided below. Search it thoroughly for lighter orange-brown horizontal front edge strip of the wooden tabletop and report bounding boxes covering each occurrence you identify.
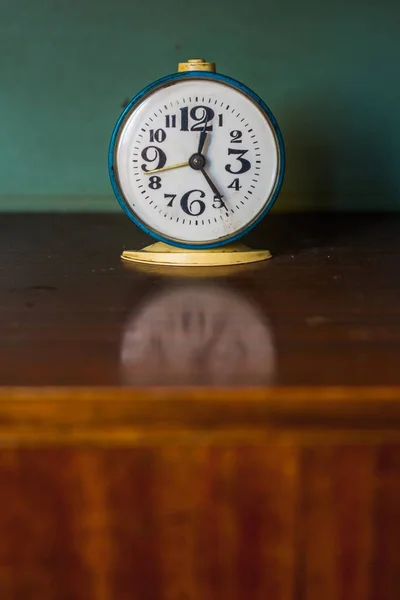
[0,387,400,447]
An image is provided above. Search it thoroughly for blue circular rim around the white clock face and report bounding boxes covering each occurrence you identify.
[108,71,285,250]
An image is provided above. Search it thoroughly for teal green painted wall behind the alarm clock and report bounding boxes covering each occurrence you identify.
[0,0,400,210]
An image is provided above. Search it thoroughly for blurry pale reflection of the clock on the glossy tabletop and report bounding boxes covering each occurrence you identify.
[120,283,275,386]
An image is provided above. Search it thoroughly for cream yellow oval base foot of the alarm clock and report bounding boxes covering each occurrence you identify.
[121,242,271,267]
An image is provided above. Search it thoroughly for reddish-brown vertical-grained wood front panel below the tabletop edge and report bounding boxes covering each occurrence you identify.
[0,443,400,600]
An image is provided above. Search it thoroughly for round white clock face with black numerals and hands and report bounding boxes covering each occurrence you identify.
[112,76,283,247]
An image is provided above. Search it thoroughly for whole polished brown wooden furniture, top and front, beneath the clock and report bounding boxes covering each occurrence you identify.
[0,215,400,600]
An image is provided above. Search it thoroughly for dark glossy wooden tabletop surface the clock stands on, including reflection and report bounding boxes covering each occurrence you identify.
[0,214,400,387]
